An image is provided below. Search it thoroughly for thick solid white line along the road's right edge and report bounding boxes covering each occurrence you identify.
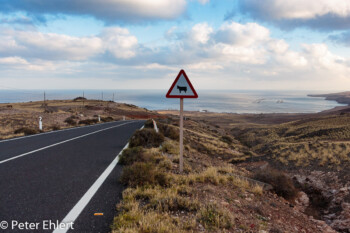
[53,126,144,233]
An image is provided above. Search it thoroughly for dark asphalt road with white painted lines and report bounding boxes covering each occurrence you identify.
[0,121,144,233]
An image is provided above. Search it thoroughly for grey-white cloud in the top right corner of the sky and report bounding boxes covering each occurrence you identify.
[226,0,350,30]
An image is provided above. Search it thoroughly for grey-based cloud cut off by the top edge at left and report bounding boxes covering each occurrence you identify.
[0,0,187,23]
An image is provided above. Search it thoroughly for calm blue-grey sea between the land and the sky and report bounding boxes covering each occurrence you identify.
[0,90,345,113]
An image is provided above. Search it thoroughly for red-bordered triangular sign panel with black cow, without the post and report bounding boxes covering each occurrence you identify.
[166,70,198,98]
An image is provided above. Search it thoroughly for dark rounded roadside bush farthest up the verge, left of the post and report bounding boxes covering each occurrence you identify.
[129,129,164,148]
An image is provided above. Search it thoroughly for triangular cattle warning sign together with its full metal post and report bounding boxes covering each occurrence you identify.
[166,70,198,173]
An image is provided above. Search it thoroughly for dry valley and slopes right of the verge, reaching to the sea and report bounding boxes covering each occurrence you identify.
[153,107,350,232]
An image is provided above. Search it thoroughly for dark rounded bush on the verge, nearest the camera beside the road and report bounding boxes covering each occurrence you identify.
[120,162,169,187]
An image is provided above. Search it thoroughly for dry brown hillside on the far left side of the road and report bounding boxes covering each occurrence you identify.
[0,98,159,139]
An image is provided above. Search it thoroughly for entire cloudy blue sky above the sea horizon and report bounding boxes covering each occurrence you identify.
[0,0,350,91]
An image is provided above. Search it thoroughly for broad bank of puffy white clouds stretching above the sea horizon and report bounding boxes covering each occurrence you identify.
[0,22,350,89]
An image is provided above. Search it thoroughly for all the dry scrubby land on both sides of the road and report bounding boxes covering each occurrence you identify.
[0,98,350,233]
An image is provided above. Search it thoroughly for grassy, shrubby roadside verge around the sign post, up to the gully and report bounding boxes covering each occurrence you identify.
[111,120,317,233]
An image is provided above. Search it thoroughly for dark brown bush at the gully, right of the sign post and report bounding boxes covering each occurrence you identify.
[254,169,298,200]
